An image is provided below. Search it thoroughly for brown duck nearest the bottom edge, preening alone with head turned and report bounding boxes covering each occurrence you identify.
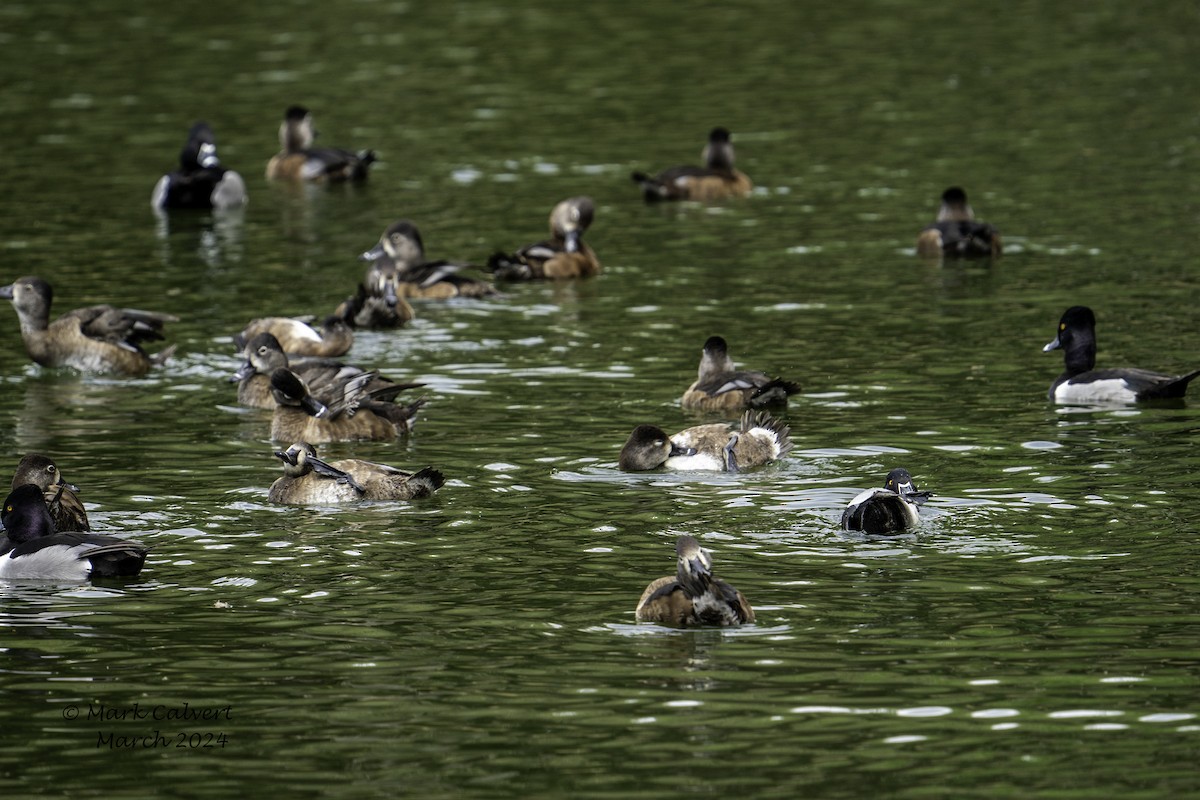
[634,535,754,627]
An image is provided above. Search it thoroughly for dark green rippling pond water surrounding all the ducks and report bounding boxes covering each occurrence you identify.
[0,0,1200,798]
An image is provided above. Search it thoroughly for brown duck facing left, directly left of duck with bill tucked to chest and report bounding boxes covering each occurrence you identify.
[359,219,498,300]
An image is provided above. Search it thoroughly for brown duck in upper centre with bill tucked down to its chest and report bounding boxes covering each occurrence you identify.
[487,196,600,281]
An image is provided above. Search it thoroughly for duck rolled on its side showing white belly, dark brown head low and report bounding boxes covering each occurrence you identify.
[618,410,792,473]
